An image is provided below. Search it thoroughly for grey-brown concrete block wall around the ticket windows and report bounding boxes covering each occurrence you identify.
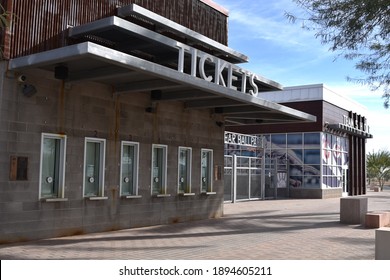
[0,63,224,243]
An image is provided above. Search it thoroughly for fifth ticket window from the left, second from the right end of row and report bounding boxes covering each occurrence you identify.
[178,147,192,194]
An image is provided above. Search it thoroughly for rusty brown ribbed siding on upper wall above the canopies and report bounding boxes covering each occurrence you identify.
[0,0,227,59]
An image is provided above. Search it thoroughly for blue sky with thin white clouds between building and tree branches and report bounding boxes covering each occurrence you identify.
[214,0,390,152]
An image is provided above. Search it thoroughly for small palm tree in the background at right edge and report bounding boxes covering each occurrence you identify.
[367,150,390,190]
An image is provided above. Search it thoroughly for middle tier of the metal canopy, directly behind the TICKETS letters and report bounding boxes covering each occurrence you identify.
[69,16,282,91]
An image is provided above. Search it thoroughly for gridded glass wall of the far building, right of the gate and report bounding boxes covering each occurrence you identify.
[264,132,349,189]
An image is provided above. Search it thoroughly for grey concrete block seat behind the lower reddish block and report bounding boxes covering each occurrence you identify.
[340,196,368,224]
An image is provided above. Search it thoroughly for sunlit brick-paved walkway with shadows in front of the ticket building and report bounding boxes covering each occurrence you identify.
[0,191,390,260]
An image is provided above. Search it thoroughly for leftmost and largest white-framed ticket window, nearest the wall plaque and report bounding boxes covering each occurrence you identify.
[39,134,66,199]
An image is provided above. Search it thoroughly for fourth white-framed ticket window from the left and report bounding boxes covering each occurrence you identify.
[151,145,168,195]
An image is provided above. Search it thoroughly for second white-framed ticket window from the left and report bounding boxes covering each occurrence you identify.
[84,138,106,197]
